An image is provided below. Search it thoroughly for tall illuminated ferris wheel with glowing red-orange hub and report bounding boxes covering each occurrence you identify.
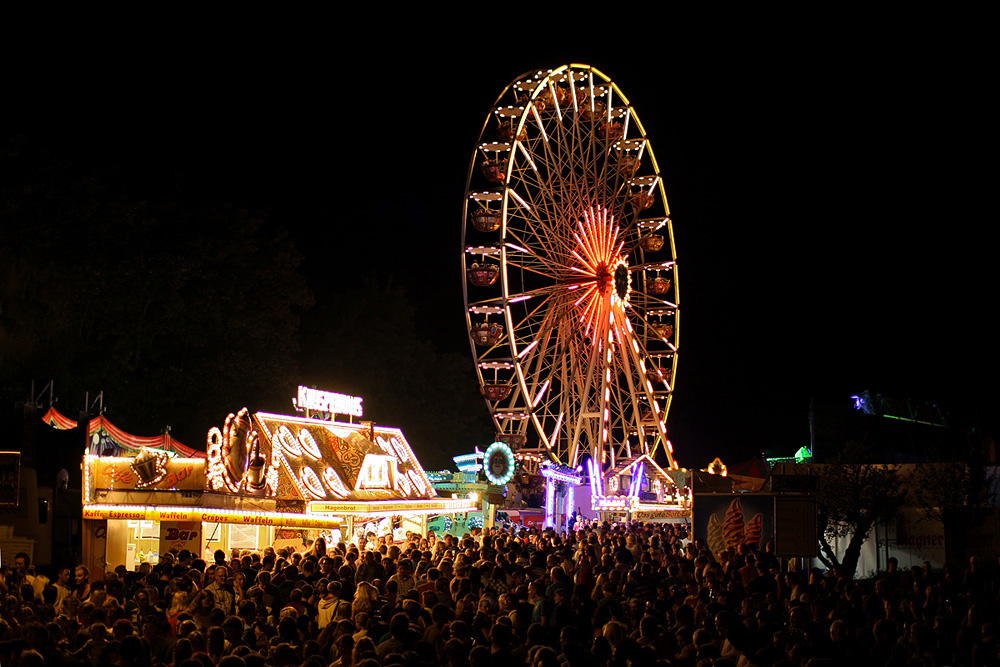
[462,64,679,468]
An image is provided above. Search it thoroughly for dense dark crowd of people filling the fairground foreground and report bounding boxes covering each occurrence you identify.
[0,523,1000,667]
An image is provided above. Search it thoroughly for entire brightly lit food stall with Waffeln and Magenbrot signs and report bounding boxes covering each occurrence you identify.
[83,390,476,572]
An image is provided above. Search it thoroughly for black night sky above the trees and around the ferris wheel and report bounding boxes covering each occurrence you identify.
[9,22,1000,466]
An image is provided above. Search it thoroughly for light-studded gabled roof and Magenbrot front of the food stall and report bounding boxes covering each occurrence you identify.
[207,411,475,543]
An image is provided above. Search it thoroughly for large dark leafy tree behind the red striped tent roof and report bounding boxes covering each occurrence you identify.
[0,136,312,447]
